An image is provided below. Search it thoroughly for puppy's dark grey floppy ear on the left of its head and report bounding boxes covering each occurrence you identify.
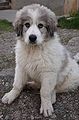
[13,11,23,37]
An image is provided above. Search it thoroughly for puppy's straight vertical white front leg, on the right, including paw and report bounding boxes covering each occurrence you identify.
[40,73,56,117]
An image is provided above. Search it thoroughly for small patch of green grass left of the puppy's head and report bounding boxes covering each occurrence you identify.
[0,20,13,32]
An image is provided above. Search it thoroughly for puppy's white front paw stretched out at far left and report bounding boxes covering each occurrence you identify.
[2,90,17,104]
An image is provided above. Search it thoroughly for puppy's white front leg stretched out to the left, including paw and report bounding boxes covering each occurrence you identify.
[2,65,27,104]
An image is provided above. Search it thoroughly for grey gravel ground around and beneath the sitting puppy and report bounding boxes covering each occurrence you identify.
[0,29,79,120]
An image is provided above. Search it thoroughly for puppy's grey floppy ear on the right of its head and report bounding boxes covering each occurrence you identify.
[47,16,57,37]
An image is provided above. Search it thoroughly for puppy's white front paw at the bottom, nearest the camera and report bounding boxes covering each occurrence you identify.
[40,101,54,117]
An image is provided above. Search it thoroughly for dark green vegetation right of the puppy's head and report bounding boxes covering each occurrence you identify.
[58,11,79,29]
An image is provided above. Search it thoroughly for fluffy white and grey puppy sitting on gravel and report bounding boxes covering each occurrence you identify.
[2,4,79,117]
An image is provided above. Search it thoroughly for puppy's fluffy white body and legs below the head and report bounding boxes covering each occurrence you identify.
[2,3,79,116]
